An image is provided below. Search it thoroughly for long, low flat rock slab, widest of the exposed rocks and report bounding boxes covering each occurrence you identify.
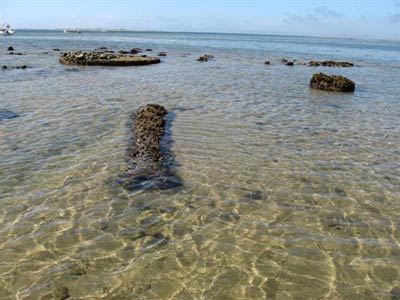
[59,51,161,67]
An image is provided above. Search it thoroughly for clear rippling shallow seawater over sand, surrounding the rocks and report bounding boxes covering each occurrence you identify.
[0,31,400,300]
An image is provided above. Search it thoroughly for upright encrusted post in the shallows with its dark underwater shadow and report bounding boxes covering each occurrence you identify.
[119,104,183,192]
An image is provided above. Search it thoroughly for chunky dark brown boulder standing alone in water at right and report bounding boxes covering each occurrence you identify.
[310,73,355,92]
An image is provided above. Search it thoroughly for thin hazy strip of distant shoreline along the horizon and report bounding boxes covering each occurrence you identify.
[9,28,400,43]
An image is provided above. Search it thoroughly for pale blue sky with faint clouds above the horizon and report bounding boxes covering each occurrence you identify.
[0,0,400,40]
